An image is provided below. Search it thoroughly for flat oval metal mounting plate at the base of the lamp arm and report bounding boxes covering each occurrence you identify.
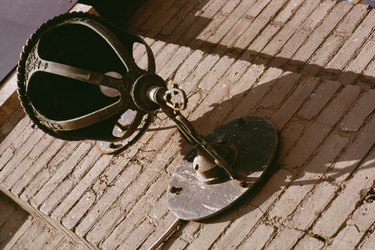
[167,117,278,220]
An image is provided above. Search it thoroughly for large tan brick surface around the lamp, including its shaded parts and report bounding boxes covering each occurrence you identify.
[0,0,375,249]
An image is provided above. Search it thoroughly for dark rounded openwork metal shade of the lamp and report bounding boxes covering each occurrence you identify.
[18,13,155,144]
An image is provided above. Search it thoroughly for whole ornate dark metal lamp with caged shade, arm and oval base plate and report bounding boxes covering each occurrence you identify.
[18,13,278,220]
